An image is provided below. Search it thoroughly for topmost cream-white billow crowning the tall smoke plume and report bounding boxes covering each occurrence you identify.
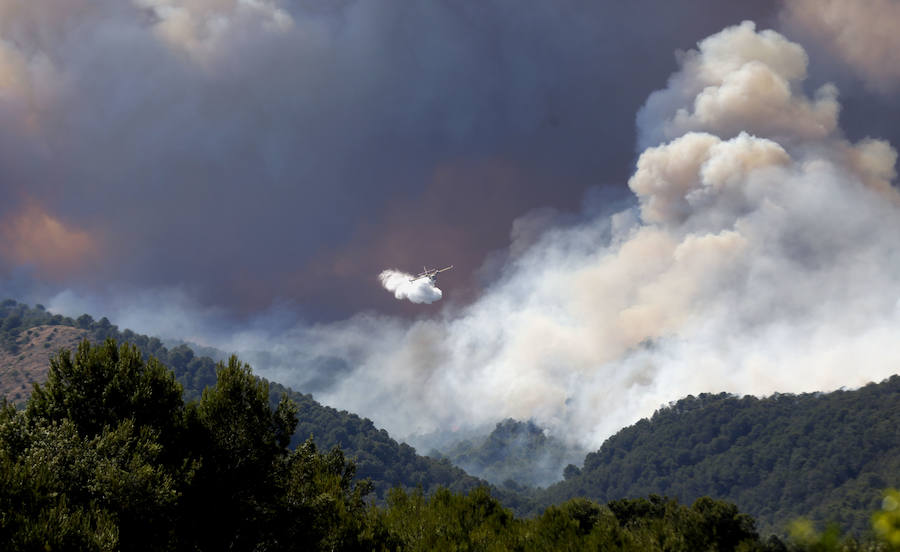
[638,22,839,150]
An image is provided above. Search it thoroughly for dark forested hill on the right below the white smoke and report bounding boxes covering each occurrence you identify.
[539,376,900,534]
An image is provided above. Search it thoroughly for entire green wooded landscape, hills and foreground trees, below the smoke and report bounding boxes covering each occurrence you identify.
[0,301,900,550]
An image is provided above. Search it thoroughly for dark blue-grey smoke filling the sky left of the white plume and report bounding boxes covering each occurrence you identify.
[0,0,775,319]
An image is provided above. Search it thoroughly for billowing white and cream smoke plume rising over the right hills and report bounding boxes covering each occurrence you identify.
[272,23,900,447]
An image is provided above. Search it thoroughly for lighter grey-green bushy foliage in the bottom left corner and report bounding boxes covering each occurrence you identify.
[0,404,177,550]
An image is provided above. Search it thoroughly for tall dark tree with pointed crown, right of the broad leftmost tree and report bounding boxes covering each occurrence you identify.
[185,356,297,550]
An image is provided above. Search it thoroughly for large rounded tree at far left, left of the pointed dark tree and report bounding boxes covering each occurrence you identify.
[0,340,193,550]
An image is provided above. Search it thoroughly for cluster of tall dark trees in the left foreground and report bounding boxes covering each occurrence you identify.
[0,340,368,550]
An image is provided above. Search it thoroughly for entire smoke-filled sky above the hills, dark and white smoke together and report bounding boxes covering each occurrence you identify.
[0,0,900,454]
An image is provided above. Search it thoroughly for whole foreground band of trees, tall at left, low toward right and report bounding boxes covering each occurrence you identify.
[0,340,852,551]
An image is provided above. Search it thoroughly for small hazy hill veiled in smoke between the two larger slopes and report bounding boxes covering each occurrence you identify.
[429,419,585,488]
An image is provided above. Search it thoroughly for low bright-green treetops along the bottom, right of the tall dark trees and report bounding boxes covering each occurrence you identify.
[370,487,785,552]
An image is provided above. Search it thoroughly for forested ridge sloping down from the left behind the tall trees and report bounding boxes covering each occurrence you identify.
[0,300,486,504]
